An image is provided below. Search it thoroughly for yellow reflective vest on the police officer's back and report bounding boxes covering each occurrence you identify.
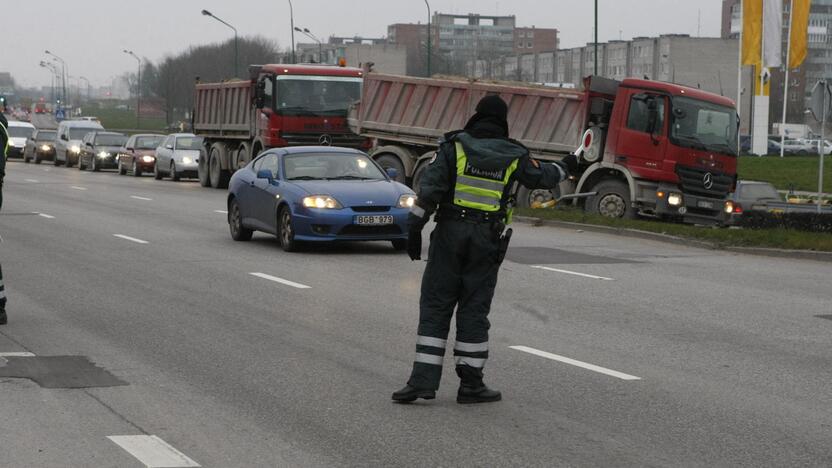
[454,142,519,224]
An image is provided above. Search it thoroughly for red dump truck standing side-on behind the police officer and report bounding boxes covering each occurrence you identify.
[349,73,737,224]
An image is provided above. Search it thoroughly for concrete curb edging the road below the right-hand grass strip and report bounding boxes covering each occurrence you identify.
[514,216,832,262]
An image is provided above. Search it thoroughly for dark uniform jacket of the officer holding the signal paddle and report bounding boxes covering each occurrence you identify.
[412,131,568,223]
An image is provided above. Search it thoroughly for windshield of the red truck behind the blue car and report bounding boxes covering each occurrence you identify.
[275,75,362,116]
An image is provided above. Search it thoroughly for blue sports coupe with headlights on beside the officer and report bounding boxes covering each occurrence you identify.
[228,146,416,252]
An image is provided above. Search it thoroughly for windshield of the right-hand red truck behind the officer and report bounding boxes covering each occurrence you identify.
[670,96,737,156]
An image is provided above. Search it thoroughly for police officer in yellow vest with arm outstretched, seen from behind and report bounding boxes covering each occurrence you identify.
[393,96,577,403]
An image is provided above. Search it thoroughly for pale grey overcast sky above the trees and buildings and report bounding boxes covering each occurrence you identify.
[8,0,722,86]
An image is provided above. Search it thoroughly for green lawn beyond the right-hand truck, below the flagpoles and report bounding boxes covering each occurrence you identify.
[737,155,832,193]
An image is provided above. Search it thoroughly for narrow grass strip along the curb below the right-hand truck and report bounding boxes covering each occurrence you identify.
[516,208,832,252]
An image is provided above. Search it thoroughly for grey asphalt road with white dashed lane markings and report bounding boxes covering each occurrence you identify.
[0,155,832,467]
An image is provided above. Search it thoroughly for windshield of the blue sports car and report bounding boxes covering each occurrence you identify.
[283,153,386,180]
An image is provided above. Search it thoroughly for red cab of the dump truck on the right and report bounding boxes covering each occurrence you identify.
[577,79,738,224]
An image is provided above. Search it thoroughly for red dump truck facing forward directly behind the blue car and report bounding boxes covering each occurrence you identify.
[193,64,370,188]
